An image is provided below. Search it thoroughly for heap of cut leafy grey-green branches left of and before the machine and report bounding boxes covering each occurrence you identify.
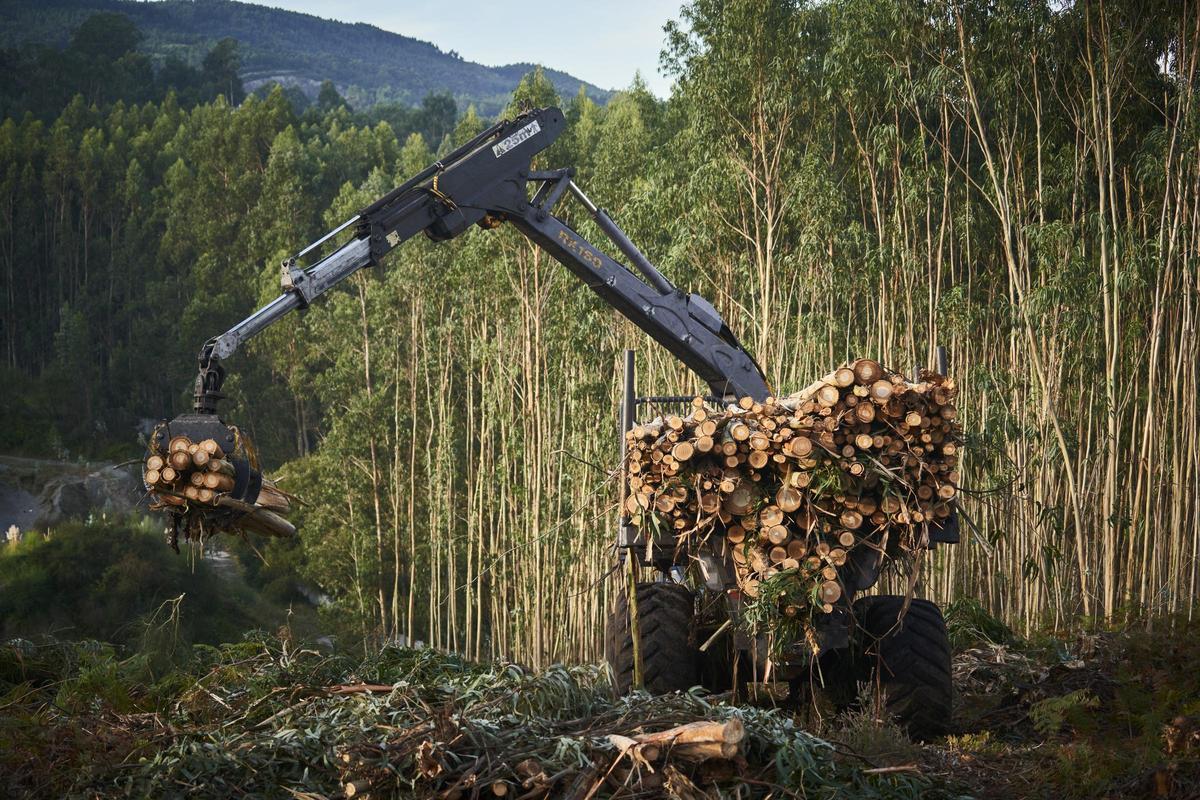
[0,633,947,800]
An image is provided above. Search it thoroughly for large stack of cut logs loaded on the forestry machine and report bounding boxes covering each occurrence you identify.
[625,359,962,615]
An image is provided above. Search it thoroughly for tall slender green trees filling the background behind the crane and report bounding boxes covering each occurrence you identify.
[0,0,1200,664]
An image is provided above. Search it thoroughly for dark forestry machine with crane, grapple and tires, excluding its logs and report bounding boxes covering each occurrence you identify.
[156,108,958,733]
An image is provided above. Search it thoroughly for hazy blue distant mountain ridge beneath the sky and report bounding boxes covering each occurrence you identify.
[0,0,612,116]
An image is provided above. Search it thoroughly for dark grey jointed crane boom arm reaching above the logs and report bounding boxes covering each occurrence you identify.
[187,107,769,414]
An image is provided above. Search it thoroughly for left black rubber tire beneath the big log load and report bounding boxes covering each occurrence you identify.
[605,583,700,694]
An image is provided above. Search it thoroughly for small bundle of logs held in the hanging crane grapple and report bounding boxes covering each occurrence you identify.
[143,437,295,547]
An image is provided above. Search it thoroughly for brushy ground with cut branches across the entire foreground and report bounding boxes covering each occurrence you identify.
[0,603,1200,800]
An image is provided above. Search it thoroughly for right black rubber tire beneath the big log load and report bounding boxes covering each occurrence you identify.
[853,595,954,739]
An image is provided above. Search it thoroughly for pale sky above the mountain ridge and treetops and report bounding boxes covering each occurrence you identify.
[252,0,683,97]
